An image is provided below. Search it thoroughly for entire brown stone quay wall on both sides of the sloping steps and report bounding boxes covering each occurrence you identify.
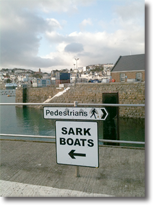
[16,82,145,118]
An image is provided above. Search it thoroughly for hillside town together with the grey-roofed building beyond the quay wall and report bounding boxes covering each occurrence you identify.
[0,54,145,88]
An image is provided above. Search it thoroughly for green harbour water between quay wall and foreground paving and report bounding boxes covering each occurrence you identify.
[0,90,145,147]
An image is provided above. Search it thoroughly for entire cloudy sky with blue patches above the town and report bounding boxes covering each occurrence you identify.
[0,0,145,72]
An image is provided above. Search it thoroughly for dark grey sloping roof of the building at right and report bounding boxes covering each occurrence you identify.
[111,54,145,72]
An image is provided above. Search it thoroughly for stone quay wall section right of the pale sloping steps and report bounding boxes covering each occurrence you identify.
[51,83,145,118]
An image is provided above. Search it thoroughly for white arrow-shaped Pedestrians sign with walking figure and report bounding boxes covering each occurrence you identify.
[44,107,108,120]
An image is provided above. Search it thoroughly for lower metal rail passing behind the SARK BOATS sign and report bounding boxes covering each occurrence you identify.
[0,133,145,145]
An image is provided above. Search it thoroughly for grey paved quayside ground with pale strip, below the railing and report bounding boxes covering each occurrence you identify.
[0,140,145,197]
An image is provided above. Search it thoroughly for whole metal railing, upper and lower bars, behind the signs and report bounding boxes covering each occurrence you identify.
[0,101,145,145]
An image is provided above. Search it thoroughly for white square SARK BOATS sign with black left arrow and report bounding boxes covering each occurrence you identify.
[56,121,99,167]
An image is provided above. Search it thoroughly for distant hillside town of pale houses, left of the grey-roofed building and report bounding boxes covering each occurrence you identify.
[0,63,113,87]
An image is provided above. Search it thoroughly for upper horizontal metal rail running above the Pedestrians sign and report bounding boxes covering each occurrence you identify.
[0,103,145,107]
